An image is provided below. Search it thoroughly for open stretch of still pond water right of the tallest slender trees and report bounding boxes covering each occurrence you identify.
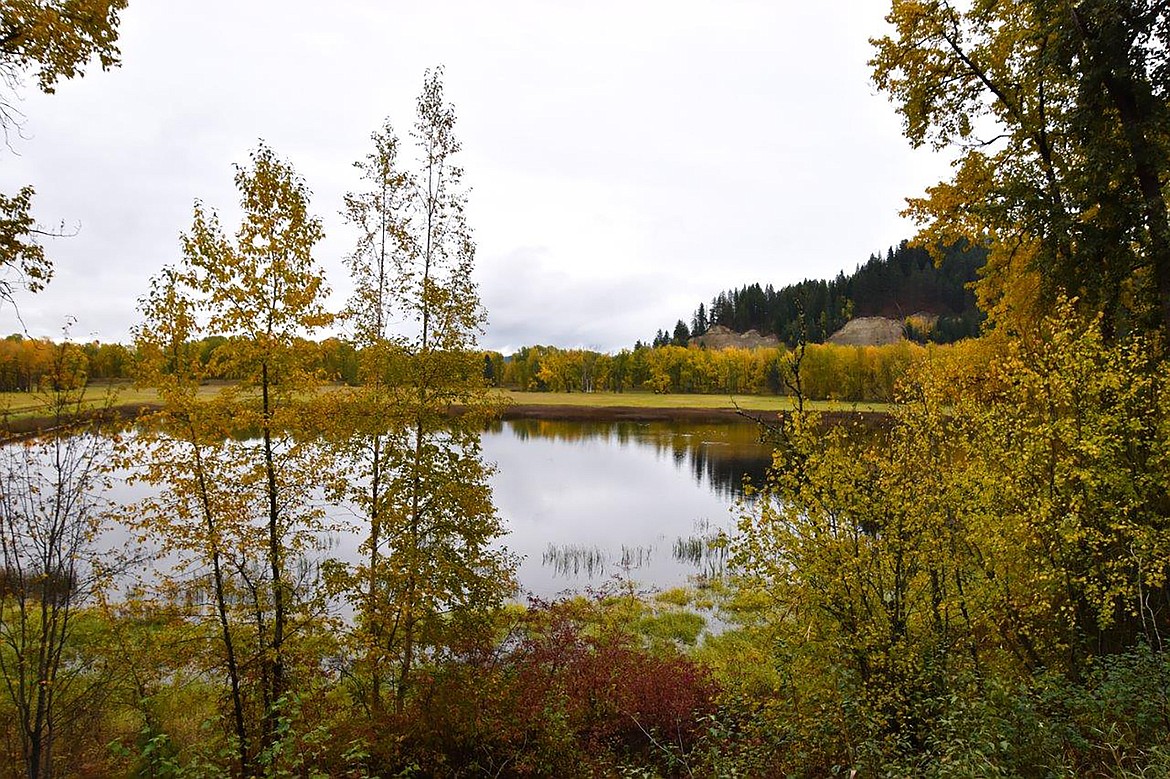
[483,420,771,598]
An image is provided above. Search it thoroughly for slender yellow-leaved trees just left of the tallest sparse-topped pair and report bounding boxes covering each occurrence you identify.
[138,144,331,762]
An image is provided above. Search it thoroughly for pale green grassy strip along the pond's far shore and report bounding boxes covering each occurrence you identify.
[0,384,889,420]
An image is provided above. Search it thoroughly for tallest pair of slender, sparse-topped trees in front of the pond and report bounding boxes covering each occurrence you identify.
[332,70,512,710]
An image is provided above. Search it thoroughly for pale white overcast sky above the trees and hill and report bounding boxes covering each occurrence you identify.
[0,0,945,351]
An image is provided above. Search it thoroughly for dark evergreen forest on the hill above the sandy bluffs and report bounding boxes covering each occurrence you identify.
[651,241,986,346]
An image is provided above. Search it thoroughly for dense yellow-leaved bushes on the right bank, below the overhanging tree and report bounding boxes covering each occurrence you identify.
[737,303,1170,684]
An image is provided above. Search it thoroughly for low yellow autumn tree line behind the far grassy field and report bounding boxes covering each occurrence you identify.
[0,336,935,401]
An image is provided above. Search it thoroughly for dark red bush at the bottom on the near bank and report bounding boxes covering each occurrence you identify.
[376,601,715,777]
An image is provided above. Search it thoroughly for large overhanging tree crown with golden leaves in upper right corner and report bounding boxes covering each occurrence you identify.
[870,0,1170,332]
